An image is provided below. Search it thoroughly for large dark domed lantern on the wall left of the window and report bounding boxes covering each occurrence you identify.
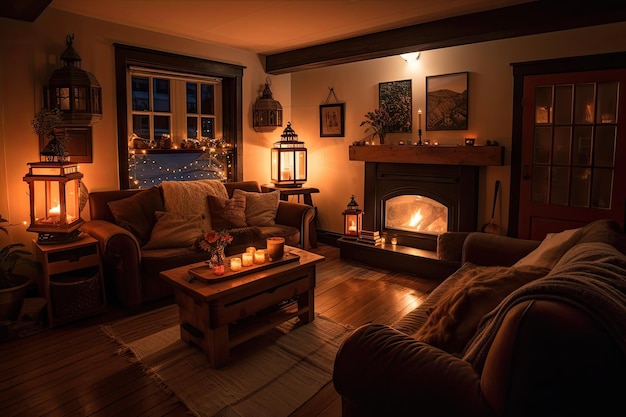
[43,34,102,126]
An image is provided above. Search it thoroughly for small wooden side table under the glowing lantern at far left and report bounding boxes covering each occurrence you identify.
[33,235,107,327]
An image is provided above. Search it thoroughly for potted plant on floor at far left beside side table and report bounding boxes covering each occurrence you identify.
[0,215,41,323]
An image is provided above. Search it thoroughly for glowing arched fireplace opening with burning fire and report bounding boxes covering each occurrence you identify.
[385,195,448,235]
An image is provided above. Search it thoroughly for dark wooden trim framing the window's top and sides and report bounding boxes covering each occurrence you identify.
[113,43,245,189]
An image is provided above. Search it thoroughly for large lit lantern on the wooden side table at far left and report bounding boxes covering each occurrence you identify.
[24,162,84,244]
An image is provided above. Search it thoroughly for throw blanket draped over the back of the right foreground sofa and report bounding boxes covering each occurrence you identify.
[463,242,626,372]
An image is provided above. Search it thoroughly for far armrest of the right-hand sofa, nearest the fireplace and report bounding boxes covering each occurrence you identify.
[462,232,541,266]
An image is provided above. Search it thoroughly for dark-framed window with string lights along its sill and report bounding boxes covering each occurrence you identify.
[115,44,243,189]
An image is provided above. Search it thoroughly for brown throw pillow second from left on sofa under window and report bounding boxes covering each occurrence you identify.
[142,211,202,249]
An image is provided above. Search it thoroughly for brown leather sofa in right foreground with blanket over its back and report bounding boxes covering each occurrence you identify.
[333,221,626,417]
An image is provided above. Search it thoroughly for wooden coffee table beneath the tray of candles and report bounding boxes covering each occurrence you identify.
[160,246,324,368]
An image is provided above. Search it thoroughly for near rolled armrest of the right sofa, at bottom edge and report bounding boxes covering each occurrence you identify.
[333,324,493,417]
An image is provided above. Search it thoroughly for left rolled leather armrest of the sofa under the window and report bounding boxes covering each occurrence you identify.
[81,220,141,307]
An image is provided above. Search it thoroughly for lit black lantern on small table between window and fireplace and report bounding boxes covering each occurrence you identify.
[271,122,307,187]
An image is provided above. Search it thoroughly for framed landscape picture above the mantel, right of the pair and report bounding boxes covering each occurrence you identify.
[426,72,469,130]
